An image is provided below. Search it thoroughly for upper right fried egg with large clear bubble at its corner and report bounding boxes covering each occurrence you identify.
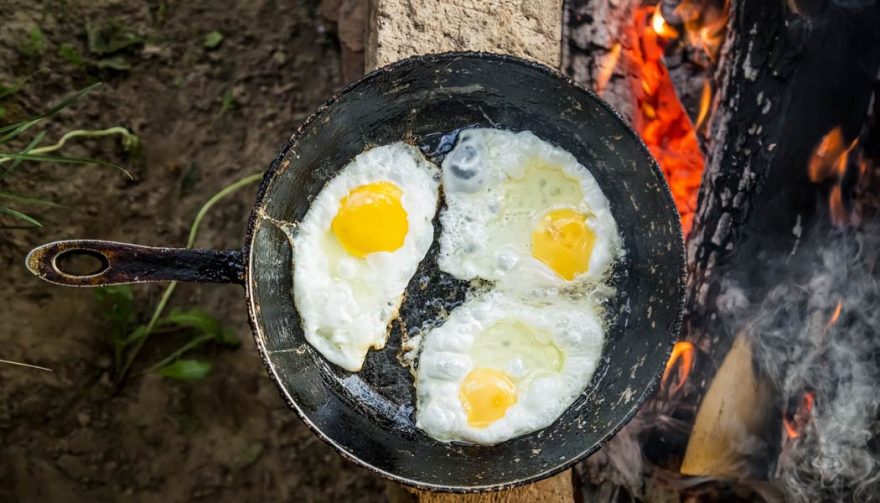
[438,129,620,288]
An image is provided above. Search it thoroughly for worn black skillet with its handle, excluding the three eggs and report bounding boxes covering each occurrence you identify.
[27,53,684,492]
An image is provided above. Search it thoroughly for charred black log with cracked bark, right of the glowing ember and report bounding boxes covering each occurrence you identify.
[685,0,880,382]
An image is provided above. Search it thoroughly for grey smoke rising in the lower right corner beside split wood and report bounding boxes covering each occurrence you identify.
[746,223,880,501]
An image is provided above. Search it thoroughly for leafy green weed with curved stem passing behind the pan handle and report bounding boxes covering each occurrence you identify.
[95,173,263,384]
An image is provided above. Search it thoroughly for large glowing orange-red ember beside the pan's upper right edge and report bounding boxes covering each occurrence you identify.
[623,6,703,233]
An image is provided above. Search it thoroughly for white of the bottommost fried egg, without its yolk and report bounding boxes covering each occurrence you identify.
[416,290,604,445]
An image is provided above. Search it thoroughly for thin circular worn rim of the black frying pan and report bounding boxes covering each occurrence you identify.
[243,51,687,494]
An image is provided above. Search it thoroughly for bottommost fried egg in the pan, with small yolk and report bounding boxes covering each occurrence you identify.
[416,290,604,445]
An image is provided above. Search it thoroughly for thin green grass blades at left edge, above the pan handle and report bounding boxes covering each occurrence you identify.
[0,82,139,227]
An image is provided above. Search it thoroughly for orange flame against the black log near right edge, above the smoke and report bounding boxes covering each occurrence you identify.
[807,126,862,227]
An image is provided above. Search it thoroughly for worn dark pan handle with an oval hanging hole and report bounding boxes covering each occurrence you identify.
[26,239,244,286]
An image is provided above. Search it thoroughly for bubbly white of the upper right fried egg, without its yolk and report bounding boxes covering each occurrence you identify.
[438,129,621,289]
